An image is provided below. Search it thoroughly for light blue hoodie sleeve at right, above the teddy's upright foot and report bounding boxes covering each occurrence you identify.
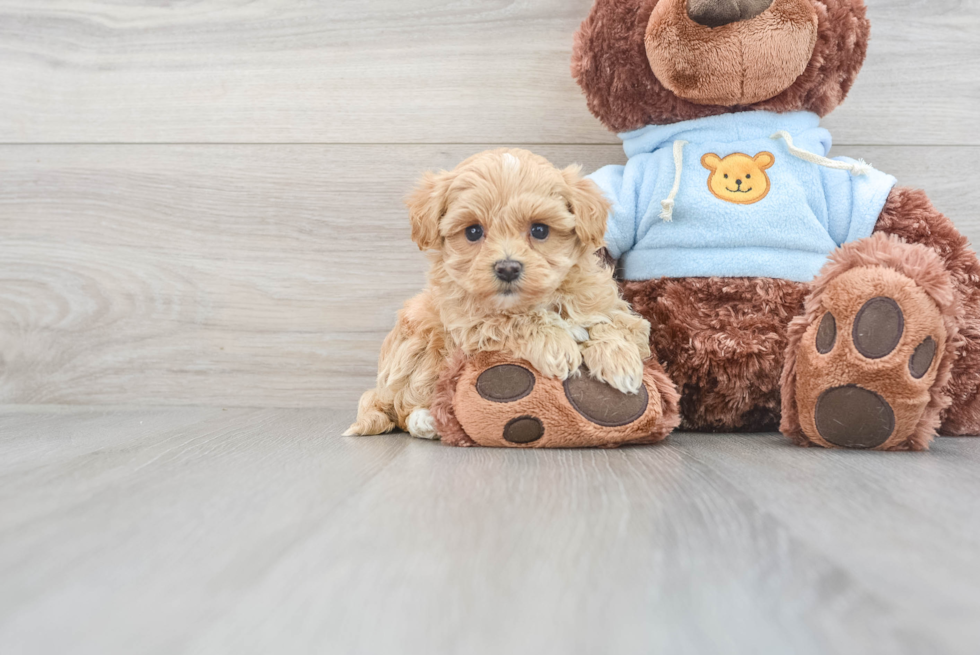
[821,157,897,246]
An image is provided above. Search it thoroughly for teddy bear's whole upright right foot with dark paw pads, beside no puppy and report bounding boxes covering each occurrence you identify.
[781,236,955,450]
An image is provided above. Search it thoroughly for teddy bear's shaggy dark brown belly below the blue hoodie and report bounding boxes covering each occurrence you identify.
[621,278,808,432]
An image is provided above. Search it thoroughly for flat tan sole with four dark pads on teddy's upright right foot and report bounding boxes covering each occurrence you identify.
[796,266,946,450]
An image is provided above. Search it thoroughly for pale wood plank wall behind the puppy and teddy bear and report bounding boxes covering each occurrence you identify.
[0,0,980,407]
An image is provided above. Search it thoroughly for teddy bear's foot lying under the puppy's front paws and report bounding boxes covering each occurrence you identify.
[431,353,680,448]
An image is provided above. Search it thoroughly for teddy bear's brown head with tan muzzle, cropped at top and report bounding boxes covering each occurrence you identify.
[572,0,870,132]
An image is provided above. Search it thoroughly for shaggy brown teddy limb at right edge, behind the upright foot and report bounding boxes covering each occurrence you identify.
[875,187,980,435]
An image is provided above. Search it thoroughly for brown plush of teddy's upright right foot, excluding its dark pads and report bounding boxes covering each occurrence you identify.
[780,233,961,450]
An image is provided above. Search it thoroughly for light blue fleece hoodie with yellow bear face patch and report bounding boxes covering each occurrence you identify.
[589,111,895,282]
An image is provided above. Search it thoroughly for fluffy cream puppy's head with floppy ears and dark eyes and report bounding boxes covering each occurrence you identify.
[408,150,608,311]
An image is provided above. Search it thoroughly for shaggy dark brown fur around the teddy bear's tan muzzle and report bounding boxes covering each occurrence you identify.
[572,0,870,132]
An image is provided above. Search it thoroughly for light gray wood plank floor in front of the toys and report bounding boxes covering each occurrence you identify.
[0,407,980,655]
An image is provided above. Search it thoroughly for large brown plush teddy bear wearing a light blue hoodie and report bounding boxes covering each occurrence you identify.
[439,0,980,450]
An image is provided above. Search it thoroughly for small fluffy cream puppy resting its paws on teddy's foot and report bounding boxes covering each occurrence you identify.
[345,149,650,439]
